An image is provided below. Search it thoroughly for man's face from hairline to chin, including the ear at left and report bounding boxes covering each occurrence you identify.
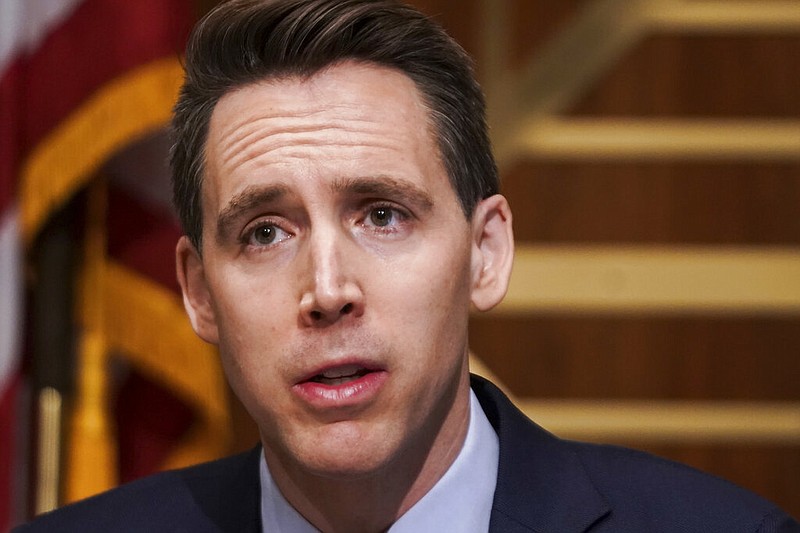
[178,62,510,476]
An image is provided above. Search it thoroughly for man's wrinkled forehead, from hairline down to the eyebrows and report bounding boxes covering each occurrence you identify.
[204,61,449,206]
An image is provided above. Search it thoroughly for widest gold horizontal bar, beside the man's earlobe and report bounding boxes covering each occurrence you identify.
[492,246,800,315]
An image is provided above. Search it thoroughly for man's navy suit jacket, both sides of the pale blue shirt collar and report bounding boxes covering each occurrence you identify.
[18,376,800,533]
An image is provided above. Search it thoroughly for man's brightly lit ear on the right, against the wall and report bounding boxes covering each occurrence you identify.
[471,194,514,311]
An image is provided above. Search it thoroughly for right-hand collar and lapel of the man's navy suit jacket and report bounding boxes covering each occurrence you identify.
[471,376,610,533]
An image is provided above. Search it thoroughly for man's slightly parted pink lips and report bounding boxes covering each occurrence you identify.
[292,363,388,410]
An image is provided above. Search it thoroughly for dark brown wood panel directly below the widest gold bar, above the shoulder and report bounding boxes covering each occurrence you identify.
[470,314,800,401]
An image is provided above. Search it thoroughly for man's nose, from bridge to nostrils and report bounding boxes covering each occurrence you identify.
[300,231,364,327]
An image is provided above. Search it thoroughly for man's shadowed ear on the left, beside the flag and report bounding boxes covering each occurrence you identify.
[175,235,219,344]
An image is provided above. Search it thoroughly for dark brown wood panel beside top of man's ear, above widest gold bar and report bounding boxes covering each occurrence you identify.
[503,160,800,245]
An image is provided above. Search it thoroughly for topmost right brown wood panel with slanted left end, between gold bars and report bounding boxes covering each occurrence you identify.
[570,34,800,119]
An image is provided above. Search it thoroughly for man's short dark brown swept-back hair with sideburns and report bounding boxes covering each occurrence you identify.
[171,0,499,250]
